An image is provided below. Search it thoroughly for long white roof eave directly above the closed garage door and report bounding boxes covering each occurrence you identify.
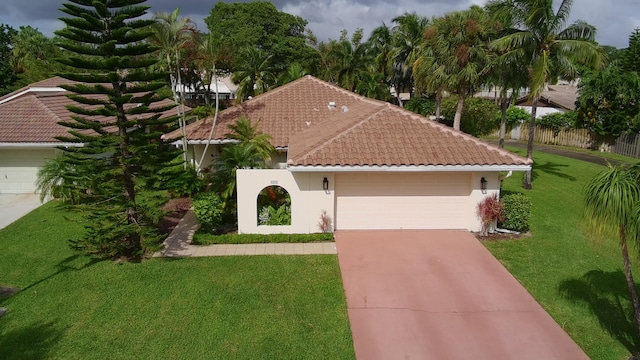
[287,164,531,172]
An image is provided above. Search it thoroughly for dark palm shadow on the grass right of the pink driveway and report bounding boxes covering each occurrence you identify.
[558,270,640,354]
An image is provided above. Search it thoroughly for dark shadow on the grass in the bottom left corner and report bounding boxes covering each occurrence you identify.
[0,320,65,360]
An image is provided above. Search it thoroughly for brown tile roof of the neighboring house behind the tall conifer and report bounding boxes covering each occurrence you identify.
[0,77,185,146]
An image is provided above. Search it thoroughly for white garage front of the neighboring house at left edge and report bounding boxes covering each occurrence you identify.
[0,149,55,194]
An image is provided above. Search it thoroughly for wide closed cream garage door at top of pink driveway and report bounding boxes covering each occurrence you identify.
[335,174,471,230]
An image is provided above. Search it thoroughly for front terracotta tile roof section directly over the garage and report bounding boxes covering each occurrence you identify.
[288,104,531,166]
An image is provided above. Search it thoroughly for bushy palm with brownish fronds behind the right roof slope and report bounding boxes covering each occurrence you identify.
[424,6,499,130]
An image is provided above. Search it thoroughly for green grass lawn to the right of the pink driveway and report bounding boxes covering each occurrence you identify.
[485,149,640,360]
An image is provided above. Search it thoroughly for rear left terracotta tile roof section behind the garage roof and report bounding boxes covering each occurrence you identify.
[167,76,375,148]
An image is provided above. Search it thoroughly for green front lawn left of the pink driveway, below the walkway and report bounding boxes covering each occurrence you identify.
[0,203,354,359]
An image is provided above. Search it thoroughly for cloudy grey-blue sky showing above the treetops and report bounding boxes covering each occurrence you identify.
[0,0,640,47]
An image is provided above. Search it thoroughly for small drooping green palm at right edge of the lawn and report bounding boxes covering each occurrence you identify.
[584,163,640,335]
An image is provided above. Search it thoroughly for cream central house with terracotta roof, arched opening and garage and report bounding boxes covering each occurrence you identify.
[168,76,531,233]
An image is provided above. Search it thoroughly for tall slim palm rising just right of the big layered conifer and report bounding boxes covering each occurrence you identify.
[149,8,195,162]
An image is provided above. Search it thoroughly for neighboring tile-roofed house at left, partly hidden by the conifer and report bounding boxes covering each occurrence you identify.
[0,77,184,194]
